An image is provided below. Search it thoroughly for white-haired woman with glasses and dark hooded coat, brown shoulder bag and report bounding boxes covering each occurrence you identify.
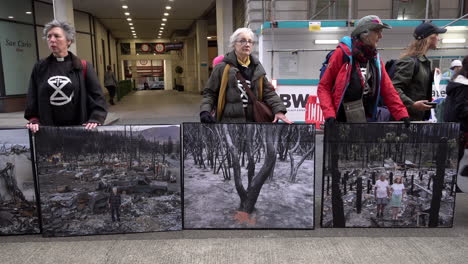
[200,28,292,123]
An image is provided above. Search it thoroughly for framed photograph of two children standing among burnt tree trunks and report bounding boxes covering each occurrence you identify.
[321,123,459,228]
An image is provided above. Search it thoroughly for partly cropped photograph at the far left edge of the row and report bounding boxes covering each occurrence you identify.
[0,129,40,235]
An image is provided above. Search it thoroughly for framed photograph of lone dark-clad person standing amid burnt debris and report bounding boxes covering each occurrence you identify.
[36,125,182,236]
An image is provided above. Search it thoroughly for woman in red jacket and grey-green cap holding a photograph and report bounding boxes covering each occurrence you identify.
[317,15,409,125]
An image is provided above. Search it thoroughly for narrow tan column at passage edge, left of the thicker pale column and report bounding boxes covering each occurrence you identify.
[196,20,208,92]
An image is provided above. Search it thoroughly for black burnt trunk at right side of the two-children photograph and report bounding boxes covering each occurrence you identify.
[429,138,448,227]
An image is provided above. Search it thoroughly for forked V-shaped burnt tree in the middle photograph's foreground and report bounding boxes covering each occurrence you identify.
[222,124,283,214]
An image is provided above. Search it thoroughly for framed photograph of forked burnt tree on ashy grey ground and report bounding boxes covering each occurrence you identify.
[182,123,315,229]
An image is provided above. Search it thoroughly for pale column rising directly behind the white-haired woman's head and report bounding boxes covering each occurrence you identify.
[216,0,233,55]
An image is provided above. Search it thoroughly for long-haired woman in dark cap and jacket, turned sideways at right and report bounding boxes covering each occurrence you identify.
[393,23,447,121]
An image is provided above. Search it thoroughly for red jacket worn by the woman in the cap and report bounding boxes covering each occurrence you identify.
[317,37,409,120]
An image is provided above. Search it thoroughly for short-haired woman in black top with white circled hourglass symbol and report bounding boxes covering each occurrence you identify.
[24,20,107,133]
